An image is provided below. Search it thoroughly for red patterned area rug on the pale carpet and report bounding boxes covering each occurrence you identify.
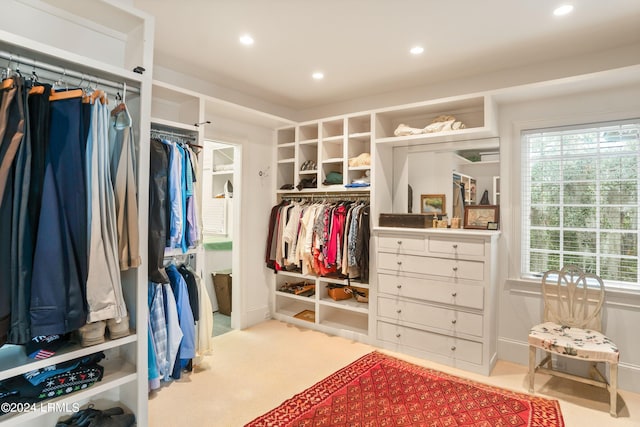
[247,351,564,427]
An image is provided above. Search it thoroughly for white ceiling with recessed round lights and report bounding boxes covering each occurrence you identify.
[133,0,640,109]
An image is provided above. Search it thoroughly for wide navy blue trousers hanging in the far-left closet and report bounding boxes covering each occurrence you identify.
[30,93,88,336]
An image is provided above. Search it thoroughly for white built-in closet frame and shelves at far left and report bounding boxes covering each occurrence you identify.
[0,0,153,427]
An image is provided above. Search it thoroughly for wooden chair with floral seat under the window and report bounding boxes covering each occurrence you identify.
[529,265,620,417]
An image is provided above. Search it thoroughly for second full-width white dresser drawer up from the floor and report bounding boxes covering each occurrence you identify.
[378,297,482,338]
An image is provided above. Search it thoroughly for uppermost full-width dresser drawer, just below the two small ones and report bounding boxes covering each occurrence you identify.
[378,252,484,280]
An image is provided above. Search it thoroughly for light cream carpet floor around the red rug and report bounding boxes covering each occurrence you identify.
[149,320,640,427]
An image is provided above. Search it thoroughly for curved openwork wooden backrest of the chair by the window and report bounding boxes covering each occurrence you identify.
[542,265,604,332]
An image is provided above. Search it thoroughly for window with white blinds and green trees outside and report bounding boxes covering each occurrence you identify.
[521,119,640,290]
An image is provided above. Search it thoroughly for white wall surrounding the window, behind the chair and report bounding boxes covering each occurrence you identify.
[498,84,640,392]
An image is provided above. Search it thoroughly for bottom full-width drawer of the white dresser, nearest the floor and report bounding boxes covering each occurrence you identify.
[377,321,482,365]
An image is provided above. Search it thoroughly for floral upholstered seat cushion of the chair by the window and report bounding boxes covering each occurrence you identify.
[529,322,620,363]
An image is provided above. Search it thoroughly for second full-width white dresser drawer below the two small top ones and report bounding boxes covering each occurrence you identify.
[378,273,484,310]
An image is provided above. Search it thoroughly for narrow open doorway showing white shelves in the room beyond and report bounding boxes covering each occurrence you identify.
[202,140,240,336]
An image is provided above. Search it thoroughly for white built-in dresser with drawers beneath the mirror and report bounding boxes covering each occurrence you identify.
[374,227,500,375]
